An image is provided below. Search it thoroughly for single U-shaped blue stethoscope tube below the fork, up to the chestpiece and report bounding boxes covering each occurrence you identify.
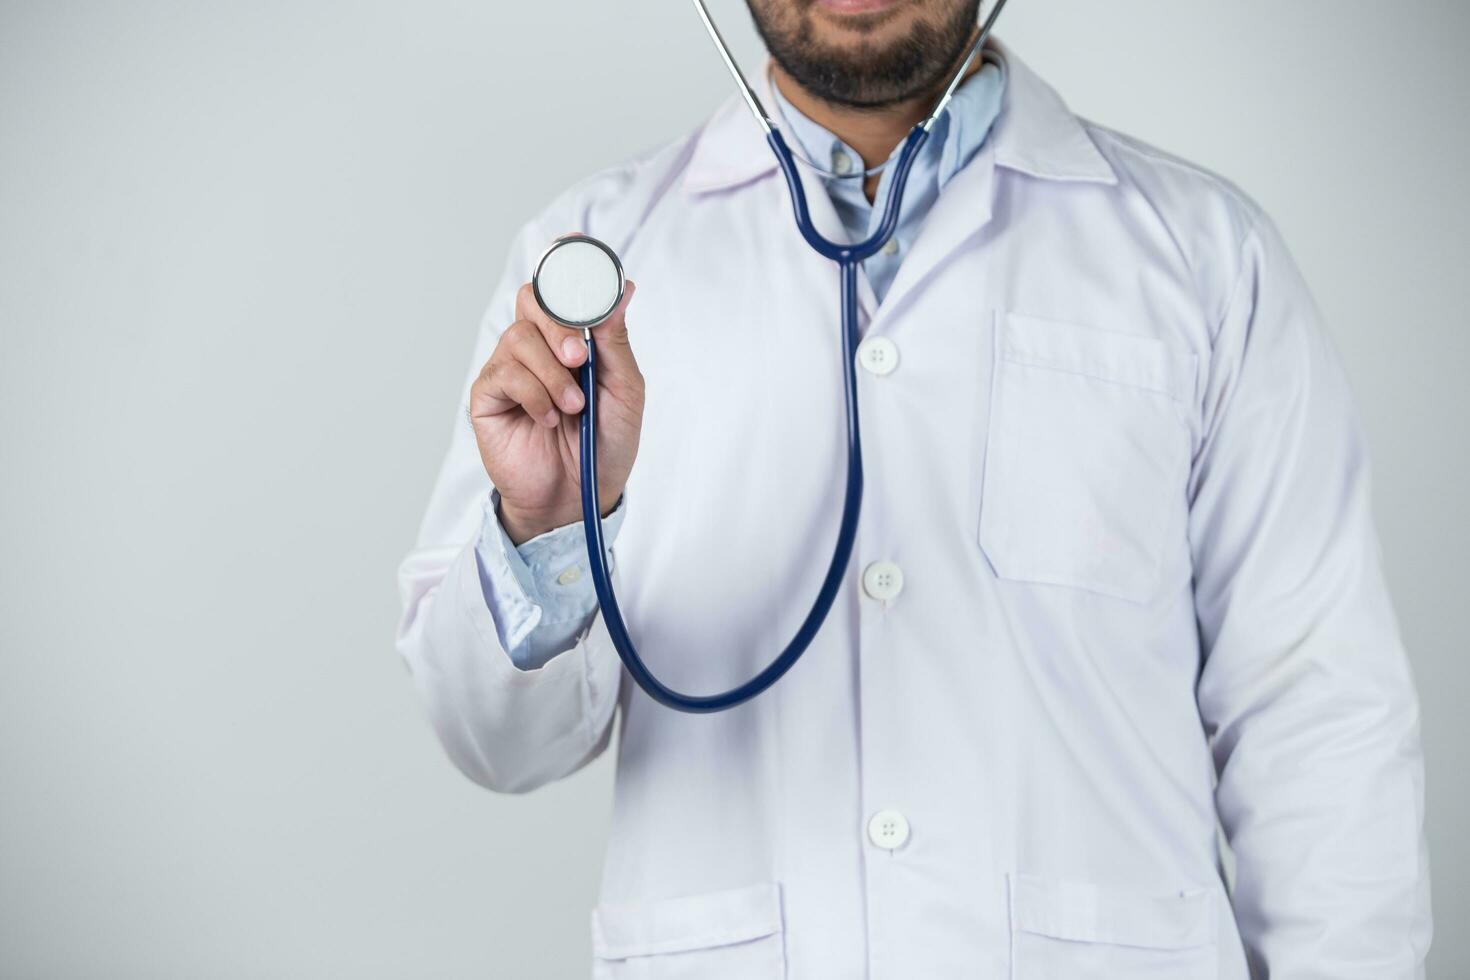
[581,262,863,714]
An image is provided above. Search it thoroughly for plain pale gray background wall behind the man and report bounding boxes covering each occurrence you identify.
[0,0,1470,980]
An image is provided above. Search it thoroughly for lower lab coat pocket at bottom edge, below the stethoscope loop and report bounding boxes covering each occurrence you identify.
[592,884,786,980]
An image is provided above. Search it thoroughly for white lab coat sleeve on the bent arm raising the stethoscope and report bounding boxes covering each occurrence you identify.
[397,219,622,792]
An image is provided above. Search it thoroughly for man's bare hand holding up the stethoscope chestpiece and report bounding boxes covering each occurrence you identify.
[469,271,644,545]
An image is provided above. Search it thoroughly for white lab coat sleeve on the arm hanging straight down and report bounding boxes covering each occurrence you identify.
[1189,215,1430,980]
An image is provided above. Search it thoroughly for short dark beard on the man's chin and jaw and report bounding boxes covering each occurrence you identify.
[748,0,980,109]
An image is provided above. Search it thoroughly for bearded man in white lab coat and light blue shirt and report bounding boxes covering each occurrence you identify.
[398,0,1430,980]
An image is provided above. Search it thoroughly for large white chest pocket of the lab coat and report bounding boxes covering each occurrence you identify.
[979,313,1195,602]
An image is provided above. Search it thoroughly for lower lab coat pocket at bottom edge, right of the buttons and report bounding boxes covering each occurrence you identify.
[1008,874,1220,980]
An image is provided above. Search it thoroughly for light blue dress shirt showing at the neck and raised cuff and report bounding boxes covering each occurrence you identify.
[476,60,1005,670]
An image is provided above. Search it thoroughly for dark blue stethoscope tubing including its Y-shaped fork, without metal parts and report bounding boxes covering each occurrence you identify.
[581,125,929,714]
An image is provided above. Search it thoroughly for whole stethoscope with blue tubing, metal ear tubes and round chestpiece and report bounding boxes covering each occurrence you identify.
[531,0,1005,713]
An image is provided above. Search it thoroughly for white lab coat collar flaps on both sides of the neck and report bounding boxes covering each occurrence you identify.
[684,37,1117,194]
